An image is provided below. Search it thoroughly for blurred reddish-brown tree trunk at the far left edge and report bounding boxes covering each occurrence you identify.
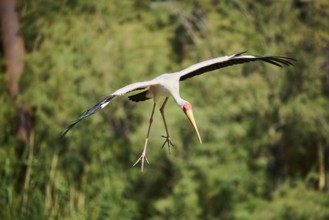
[0,0,35,201]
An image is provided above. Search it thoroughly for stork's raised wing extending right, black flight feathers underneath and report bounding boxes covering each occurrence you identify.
[180,51,295,81]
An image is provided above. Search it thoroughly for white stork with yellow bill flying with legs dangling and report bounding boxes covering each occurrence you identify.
[62,51,295,172]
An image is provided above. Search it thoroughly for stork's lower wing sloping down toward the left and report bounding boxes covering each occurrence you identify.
[62,80,157,136]
